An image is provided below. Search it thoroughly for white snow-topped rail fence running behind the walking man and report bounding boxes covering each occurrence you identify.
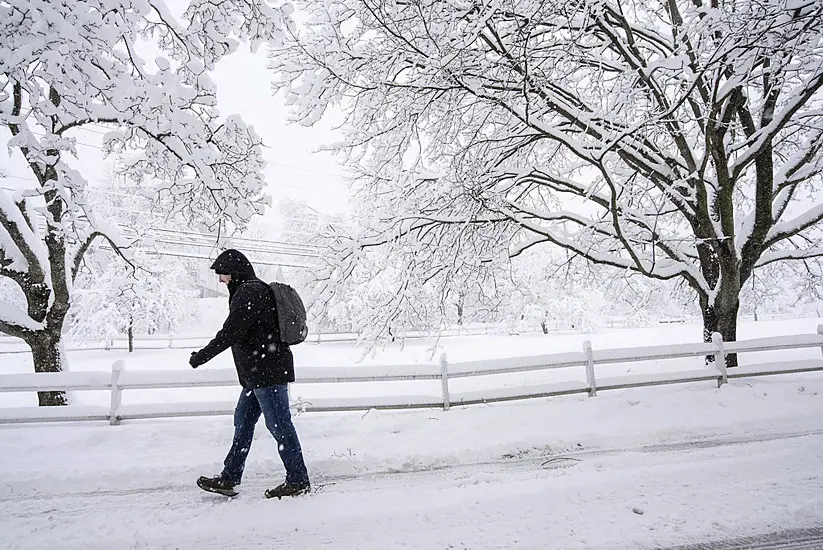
[0,325,823,425]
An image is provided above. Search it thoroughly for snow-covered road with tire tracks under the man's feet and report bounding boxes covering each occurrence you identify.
[6,431,823,549]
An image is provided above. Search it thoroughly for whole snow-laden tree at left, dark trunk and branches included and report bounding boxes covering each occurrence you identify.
[0,0,291,405]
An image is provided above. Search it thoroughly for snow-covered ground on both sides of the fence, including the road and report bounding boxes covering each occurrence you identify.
[0,319,823,549]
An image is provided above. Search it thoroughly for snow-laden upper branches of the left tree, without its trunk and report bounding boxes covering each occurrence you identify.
[0,0,289,233]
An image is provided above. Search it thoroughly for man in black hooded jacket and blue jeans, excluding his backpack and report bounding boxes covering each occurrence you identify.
[189,249,311,498]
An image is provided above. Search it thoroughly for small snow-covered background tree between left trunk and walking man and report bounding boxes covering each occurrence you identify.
[68,163,203,351]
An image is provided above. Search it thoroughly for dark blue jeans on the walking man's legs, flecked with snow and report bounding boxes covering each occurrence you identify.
[222,384,309,483]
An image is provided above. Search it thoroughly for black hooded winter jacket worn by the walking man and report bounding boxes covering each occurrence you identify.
[190,249,294,389]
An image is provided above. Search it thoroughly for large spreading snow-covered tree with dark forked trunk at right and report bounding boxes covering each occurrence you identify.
[271,0,823,370]
